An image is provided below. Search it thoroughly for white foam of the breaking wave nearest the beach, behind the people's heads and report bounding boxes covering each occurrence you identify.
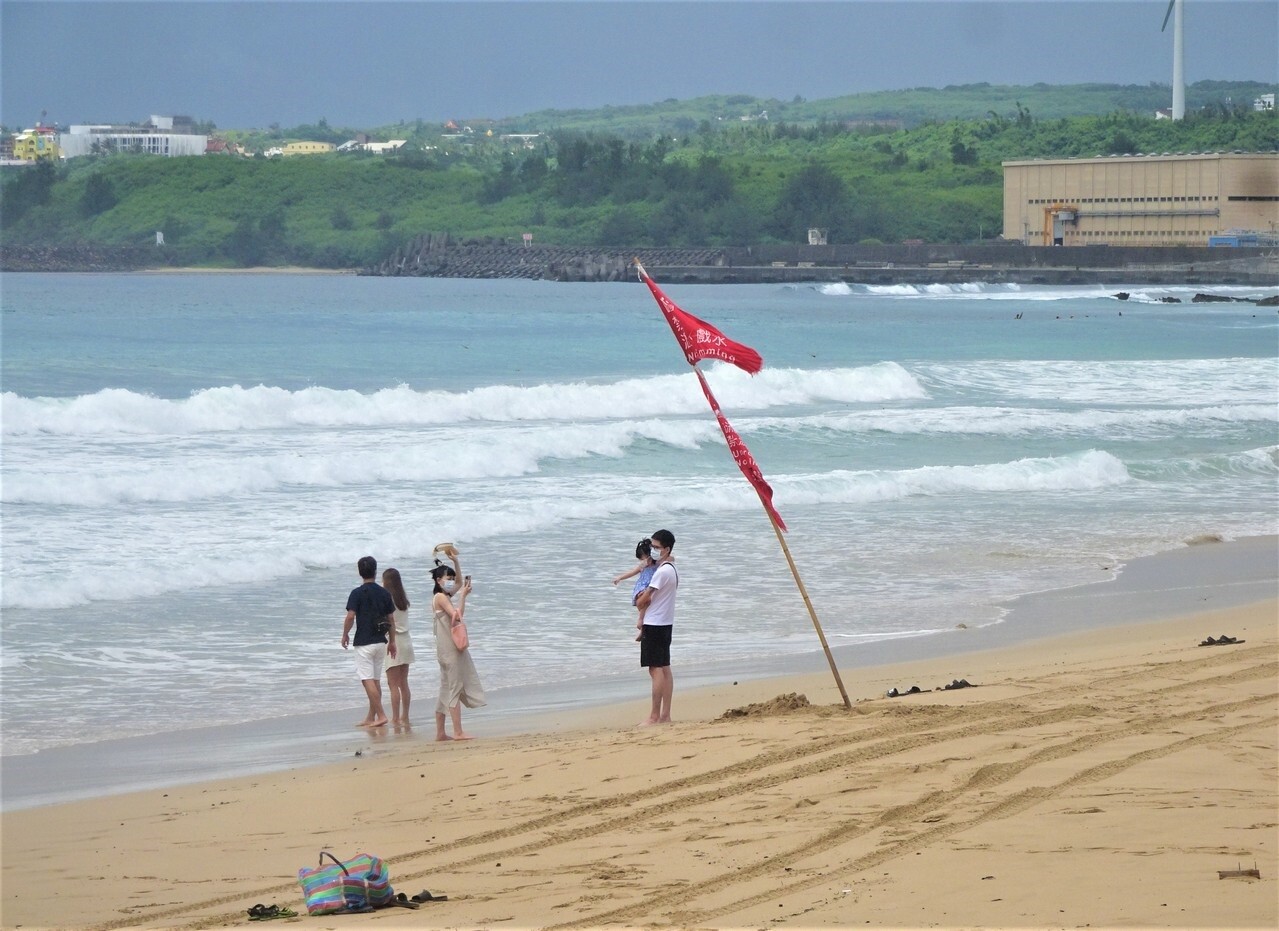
[4,450,1129,609]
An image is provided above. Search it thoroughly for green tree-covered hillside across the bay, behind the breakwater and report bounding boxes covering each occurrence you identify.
[0,84,1279,267]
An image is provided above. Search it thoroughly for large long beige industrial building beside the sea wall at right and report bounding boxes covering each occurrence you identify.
[1004,152,1279,246]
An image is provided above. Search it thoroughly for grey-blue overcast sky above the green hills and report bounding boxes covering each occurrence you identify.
[0,0,1279,129]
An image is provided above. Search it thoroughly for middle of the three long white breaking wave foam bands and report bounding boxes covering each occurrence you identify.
[3,393,1279,508]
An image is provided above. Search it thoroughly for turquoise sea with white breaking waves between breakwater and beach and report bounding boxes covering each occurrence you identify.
[0,274,1279,755]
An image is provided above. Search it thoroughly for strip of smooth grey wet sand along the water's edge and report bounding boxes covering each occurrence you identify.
[0,537,1279,811]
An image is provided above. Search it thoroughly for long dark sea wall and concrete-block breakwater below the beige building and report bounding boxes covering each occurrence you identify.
[361,234,1279,288]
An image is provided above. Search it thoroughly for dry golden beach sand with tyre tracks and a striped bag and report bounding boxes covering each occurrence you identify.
[0,600,1279,931]
